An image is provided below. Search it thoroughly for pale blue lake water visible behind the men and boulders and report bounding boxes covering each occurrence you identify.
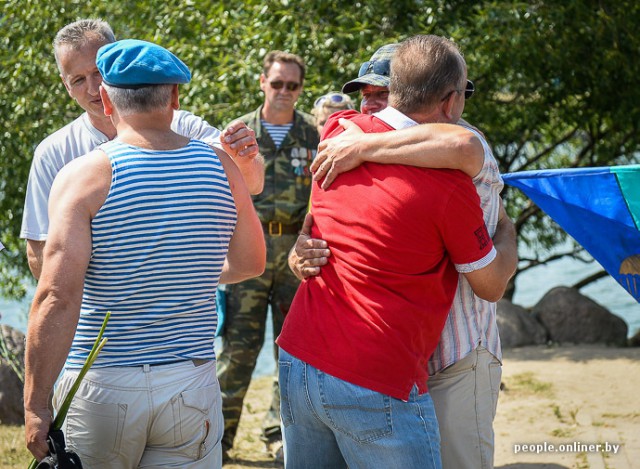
[0,259,640,376]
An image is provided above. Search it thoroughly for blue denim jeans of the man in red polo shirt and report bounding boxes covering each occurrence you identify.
[278,349,442,469]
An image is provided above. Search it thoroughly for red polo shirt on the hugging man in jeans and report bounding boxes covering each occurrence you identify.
[277,111,493,400]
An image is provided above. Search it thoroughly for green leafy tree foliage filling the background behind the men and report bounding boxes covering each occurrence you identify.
[0,0,640,296]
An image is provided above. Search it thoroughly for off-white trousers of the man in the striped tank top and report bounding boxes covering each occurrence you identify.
[53,360,224,469]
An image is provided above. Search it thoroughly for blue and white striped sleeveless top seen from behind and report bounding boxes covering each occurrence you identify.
[65,140,237,368]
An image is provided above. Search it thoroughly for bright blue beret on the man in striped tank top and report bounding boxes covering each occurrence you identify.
[96,39,191,88]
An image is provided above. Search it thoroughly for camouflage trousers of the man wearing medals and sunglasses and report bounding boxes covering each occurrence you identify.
[217,235,300,450]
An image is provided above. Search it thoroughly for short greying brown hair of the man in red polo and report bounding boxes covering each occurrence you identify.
[389,35,467,114]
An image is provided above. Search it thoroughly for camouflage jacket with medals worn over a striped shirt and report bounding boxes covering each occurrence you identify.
[234,106,320,225]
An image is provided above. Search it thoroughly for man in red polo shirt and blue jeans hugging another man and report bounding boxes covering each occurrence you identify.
[277,36,510,468]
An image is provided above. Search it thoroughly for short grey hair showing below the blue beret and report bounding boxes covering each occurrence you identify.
[102,81,175,116]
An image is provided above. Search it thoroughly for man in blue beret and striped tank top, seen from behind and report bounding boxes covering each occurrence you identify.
[24,40,266,469]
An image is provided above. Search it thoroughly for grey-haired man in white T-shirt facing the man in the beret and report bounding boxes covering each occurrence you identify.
[20,19,264,279]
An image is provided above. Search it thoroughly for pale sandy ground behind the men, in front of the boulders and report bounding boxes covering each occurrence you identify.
[225,346,640,469]
